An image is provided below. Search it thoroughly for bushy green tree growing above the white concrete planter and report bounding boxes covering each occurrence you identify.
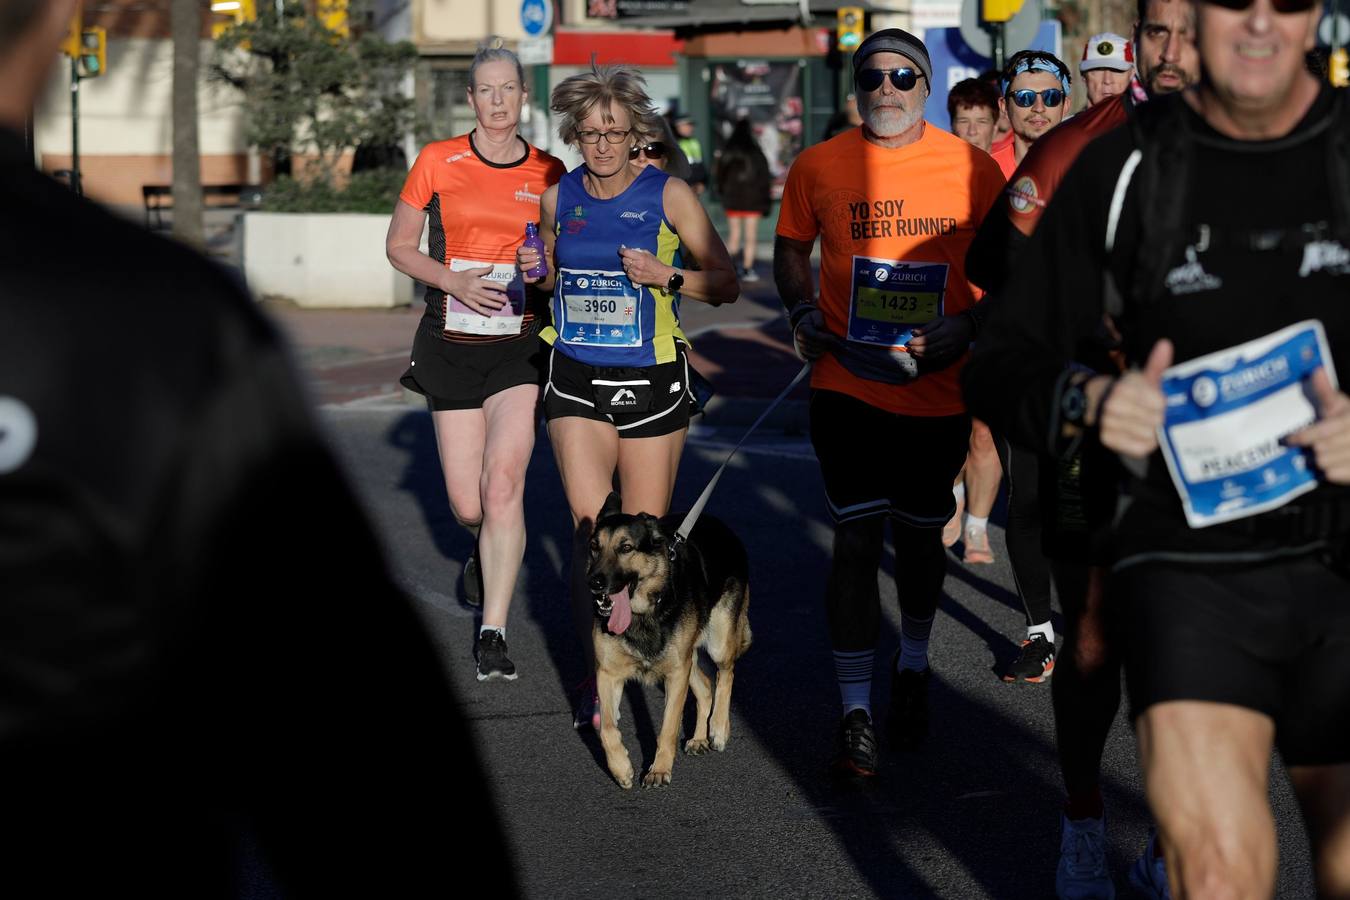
[212,0,417,181]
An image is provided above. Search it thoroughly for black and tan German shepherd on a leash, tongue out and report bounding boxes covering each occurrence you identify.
[586,494,751,791]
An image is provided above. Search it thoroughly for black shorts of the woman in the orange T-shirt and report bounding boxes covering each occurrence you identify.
[398,318,548,410]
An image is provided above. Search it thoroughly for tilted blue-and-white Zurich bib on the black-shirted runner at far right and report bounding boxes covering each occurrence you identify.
[1158,320,1337,528]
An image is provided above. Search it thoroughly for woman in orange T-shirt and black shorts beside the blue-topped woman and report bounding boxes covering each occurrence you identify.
[385,38,566,681]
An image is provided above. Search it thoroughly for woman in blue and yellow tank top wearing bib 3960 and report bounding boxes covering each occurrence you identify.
[517,66,740,729]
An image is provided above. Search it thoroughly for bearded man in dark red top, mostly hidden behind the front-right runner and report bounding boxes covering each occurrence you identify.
[967,0,1200,900]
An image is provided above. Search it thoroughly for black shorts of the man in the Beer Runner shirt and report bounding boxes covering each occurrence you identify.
[810,390,971,528]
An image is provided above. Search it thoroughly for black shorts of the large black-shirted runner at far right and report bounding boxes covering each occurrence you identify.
[1108,556,1350,765]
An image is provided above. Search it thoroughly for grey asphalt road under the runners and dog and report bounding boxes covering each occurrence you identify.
[310,402,1311,899]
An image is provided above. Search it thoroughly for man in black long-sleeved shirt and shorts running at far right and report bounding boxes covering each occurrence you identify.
[967,0,1350,897]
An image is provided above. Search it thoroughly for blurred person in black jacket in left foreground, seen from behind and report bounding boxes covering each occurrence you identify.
[0,0,512,897]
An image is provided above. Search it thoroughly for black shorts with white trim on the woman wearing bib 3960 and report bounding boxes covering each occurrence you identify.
[544,344,694,437]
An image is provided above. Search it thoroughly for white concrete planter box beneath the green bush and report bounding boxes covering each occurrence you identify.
[243,212,413,308]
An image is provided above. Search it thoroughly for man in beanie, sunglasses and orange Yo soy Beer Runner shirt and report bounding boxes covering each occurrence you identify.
[774,28,1003,781]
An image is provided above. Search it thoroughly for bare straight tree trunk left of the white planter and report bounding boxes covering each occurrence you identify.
[171,0,205,247]
